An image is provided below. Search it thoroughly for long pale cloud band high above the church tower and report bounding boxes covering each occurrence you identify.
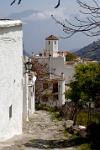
[9,4,79,22]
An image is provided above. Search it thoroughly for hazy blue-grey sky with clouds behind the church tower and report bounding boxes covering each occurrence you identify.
[0,0,99,54]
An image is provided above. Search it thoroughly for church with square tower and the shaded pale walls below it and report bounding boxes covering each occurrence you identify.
[38,35,75,84]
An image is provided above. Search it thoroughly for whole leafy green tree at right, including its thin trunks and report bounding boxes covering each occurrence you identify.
[66,63,100,124]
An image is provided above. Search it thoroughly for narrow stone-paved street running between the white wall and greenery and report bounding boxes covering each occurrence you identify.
[0,111,75,150]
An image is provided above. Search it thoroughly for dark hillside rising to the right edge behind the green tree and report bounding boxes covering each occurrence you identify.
[74,40,100,61]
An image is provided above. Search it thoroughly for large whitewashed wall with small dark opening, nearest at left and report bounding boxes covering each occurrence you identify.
[0,20,23,141]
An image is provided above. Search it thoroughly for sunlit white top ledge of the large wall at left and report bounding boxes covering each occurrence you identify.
[0,19,22,28]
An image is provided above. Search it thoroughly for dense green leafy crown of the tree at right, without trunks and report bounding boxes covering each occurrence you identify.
[75,63,100,101]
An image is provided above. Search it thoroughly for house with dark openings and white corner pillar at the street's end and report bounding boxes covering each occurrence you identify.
[38,74,65,108]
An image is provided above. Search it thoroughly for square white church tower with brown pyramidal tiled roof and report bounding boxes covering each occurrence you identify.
[44,35,59,57]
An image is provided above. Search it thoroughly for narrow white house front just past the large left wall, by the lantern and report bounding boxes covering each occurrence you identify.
[23,56,36,121]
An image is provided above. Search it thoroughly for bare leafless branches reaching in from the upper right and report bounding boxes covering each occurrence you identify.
[51,0,100,38]
